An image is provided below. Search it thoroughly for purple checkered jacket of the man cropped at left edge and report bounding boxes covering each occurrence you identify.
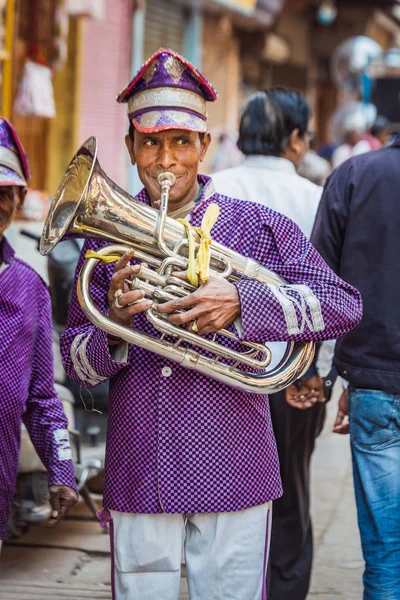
[0,238,76,540]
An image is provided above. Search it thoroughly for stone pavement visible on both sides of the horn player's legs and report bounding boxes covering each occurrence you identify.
[0,386,362,600]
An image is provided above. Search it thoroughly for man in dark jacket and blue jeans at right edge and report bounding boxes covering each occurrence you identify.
[311,136,400,600]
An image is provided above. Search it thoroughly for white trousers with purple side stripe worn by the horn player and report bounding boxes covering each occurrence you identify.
[110,502,272,600]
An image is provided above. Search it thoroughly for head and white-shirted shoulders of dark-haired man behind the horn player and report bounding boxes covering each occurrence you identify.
[212,88,322,237]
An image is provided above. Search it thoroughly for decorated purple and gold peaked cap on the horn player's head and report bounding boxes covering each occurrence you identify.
[117,48,217,133]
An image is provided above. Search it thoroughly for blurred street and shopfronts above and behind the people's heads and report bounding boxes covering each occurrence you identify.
[0,0,400,279]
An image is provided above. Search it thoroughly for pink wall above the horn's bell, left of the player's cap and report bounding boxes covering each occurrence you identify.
[79,0,132,187]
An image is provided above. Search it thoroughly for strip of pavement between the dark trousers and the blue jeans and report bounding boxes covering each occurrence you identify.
[308,386,364,600]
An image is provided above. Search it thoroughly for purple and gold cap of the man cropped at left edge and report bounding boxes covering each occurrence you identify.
[0,117,31,187]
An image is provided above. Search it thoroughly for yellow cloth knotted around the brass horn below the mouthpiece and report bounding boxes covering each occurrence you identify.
[177,204,220,287]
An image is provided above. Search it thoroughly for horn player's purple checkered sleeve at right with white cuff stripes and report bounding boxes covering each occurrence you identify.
[235,213,362,342]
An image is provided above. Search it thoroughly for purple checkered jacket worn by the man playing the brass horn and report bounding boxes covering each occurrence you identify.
[61,176,361,513]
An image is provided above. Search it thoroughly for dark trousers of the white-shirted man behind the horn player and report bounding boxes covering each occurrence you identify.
[268,392,325,600]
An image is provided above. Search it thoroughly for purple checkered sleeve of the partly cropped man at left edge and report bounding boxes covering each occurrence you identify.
[23,283,78,493]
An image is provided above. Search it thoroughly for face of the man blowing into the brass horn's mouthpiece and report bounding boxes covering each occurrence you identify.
[125,129,211,208]
